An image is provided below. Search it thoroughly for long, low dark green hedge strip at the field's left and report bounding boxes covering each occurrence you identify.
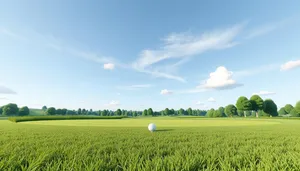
[8,116,126,122]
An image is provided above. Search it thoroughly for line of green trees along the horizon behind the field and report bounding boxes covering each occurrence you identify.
[0,95,300,117]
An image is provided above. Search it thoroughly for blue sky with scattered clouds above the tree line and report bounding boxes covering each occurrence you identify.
[0,0,300,110]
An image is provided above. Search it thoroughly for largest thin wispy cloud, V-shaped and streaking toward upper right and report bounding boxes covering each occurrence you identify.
[132,24,243,82]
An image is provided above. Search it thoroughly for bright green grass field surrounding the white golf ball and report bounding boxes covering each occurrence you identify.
[0,117,300,171]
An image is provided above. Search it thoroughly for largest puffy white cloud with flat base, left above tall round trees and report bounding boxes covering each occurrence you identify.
[198,66,242,90]
